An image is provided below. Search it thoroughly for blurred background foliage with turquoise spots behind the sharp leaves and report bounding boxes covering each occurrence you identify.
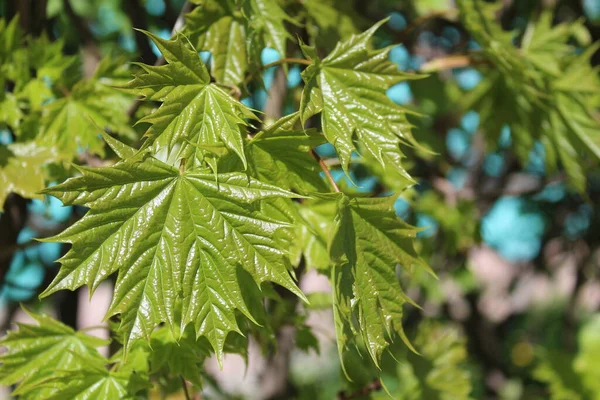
[0,0,600,400]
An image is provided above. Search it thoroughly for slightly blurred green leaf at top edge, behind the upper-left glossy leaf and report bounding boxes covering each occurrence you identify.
[184,0,248,85]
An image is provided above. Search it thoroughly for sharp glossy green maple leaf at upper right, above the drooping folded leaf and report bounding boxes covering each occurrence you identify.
[300,21,418,181]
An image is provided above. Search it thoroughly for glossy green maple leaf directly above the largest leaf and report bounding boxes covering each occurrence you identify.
[127,32,256,166]
